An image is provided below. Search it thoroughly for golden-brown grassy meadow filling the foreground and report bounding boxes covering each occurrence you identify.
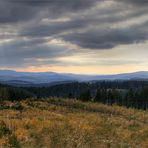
[0,98,148,148]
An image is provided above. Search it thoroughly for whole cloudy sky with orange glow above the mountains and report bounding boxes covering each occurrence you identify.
[0,0,148,74]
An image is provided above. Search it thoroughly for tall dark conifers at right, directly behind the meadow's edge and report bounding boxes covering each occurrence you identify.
[78,87,148,109]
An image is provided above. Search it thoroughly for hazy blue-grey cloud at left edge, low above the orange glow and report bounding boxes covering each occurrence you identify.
[0,36,73,67]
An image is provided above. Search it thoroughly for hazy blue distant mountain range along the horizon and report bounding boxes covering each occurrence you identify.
[0,70,148,86]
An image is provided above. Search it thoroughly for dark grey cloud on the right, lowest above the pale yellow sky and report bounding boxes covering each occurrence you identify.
[59,22,148,49]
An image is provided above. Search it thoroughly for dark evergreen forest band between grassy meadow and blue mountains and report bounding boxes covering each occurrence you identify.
[0,81,148,109]
